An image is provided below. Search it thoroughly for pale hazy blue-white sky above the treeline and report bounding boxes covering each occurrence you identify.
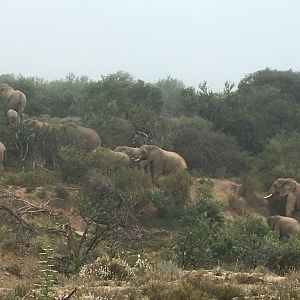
[0,0,300,90]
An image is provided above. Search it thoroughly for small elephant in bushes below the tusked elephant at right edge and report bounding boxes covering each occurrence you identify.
[267,215,300,237]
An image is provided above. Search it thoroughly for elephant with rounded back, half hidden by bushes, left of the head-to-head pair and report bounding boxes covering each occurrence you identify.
[57,122,101,151]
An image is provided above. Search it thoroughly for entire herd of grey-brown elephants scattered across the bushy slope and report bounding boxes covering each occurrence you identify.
[0,83,300,236]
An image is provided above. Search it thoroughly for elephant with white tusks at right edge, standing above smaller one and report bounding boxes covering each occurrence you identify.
[264,178,300,217]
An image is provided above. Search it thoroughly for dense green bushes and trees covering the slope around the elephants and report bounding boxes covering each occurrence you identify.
[0,69,300,299]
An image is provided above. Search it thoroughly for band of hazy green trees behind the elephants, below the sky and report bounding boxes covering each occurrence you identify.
[0,69,300,185]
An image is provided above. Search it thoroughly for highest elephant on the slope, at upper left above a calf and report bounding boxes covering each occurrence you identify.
[0,83,27,119]
